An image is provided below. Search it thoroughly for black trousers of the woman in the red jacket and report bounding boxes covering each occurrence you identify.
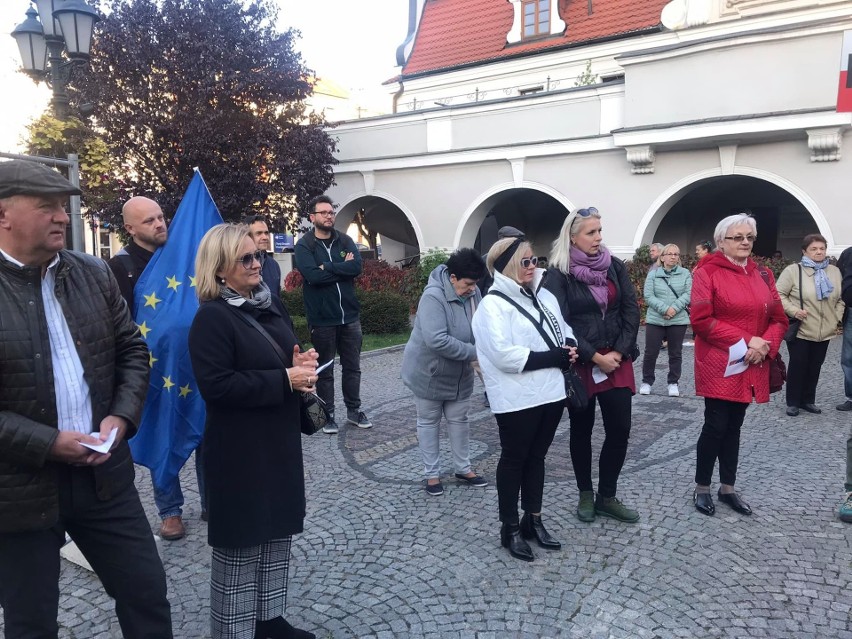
[695,397,748,486]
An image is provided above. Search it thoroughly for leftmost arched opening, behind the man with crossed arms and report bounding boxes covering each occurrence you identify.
[335,195,421,266]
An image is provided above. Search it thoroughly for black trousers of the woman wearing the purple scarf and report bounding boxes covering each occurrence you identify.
[568,388,633,497]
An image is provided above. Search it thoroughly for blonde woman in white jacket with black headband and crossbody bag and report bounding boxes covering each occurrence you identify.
[473,238,577,561]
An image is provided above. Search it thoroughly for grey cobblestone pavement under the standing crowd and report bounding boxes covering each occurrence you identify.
[6,335,852,639]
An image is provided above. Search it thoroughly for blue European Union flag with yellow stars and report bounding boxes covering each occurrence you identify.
[130,170,222,498]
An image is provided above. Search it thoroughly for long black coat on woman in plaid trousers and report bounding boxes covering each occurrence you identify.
[189,296,305,548]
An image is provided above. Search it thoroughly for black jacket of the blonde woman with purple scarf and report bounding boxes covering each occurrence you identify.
[544,257,639,362]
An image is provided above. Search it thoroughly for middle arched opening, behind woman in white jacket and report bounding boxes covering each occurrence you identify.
[458,186,572,256]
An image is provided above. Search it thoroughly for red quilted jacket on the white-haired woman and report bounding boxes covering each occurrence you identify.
[689,252,787,404]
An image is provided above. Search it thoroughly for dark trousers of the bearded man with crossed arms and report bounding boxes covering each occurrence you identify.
[311,321,363,412]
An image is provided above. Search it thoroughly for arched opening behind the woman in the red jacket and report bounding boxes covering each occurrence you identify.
[640,175,820,259]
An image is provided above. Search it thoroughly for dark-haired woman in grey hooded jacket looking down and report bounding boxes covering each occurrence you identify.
[402,248,488,496]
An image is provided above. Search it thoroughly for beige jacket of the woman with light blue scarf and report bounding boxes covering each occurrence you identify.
[776,264,844,342]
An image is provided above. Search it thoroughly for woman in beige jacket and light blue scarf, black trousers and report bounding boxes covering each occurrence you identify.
[776,233,844,417]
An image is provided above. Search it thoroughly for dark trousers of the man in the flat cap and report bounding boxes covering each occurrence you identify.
[0,465,172,639]
